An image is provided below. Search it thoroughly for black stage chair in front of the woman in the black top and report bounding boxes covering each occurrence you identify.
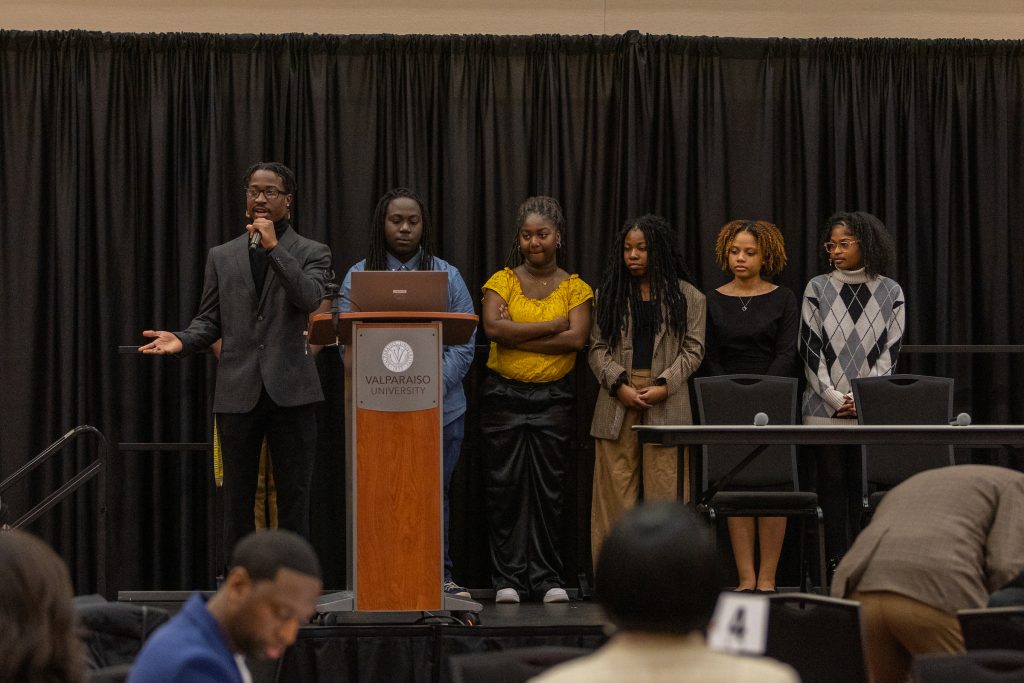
[694,375,828,593]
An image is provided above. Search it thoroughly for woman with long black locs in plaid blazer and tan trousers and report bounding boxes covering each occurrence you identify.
[588,215,705,563]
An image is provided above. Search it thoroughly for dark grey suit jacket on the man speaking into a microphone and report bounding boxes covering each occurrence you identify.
[174,226,331,413]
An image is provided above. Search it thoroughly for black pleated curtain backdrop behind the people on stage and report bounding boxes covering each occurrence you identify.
[0,32,1024,592]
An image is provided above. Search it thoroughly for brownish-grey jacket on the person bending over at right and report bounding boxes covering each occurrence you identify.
[831,465,1024,613]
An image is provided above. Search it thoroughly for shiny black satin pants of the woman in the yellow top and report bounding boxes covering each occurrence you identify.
[480,374,574,597]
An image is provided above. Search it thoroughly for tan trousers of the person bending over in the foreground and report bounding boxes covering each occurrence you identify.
[850,591,965,683]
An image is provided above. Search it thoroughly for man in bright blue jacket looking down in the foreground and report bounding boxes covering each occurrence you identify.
[128,529,321,683]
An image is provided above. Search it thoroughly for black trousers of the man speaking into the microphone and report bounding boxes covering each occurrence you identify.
[217,389,316,557]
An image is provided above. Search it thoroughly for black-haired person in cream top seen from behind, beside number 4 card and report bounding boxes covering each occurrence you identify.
[536,502,800,683]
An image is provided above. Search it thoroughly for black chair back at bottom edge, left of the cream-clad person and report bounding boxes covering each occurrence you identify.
[449,647,594,683]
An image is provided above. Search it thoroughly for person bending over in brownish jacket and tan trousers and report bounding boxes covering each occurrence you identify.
[831,465,1024,683]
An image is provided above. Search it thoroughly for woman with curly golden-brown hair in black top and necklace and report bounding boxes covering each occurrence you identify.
[706,220,800,593]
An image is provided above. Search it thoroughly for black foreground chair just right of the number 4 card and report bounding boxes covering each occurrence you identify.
[765,593,867,683]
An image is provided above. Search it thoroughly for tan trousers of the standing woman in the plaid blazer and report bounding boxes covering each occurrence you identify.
[590,370,690,567]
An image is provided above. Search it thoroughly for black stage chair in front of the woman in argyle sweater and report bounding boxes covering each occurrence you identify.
[852,375,955,527]
